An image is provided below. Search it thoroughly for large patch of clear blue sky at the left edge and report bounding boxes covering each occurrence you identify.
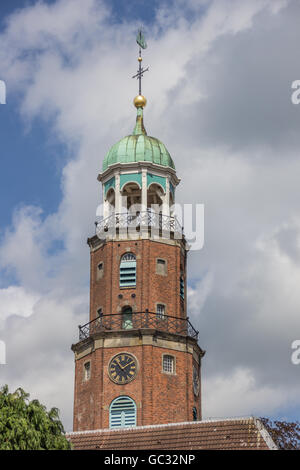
[0,98,64,229]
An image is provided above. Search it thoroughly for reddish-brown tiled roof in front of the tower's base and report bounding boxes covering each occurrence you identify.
[67,418,276,450]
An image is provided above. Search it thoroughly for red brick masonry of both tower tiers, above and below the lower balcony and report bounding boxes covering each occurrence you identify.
[72,238,203,431]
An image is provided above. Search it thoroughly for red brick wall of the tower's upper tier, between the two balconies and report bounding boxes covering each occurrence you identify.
[90,240,186,320]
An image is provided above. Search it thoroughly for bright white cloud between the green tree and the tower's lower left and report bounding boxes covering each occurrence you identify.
[0,286,87,430]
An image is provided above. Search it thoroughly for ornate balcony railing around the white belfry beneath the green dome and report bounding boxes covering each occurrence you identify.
[95,210,183,239]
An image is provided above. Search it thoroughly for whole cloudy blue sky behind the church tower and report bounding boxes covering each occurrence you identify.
[0,0,300,430]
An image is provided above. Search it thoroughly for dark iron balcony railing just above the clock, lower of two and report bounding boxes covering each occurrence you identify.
[79,311,199,341]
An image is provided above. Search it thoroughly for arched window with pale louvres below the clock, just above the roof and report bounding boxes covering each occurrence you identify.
[109,396,136,428]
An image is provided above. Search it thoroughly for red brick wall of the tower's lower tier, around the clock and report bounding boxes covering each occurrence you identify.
[74,345,200,431]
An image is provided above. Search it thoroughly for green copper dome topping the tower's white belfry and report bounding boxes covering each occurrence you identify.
[103,108,175,171]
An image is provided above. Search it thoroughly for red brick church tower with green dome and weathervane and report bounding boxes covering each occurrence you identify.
[72,33,204,431]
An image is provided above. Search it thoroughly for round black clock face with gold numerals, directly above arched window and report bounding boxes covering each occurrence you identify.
[108,353,138,385]
